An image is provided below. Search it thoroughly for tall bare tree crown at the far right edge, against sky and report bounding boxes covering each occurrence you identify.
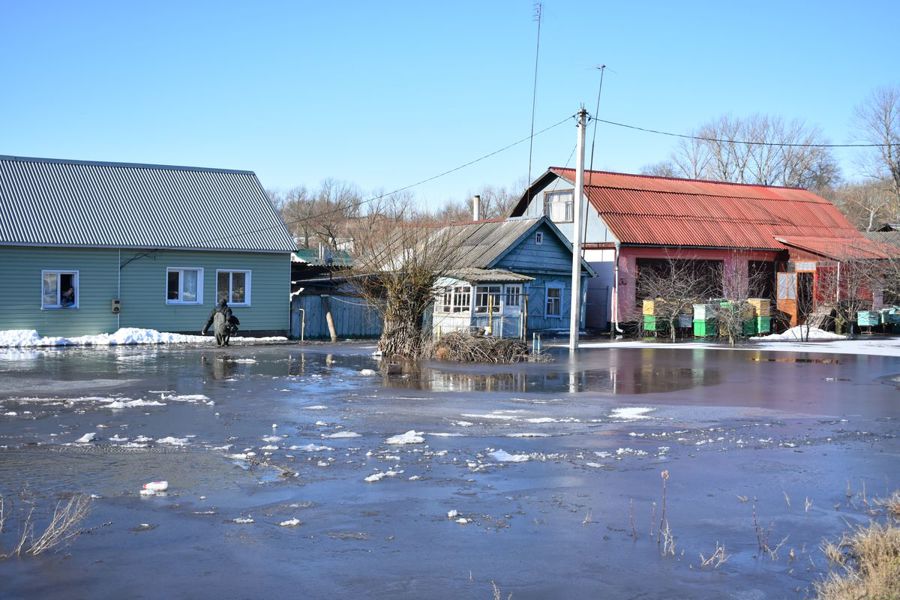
[855,86,900,199]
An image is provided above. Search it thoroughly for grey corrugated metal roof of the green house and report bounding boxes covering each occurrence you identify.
[0,156,296,252]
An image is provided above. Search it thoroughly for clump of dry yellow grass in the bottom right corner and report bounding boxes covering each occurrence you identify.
[815,522,900,600]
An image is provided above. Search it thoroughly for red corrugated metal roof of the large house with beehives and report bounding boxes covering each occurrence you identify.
[550,167,878,257]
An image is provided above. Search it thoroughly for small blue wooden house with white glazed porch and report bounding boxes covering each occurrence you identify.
[432,217,594,337]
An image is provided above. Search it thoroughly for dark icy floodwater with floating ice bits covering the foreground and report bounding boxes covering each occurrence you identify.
[0,345,900,600]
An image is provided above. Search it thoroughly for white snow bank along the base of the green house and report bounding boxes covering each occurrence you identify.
[0,327,287,348]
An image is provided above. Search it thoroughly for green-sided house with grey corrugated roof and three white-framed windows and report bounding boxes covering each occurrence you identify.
[0,156,296,337]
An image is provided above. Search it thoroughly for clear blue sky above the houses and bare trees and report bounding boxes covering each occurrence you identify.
[0,0,900,211]
